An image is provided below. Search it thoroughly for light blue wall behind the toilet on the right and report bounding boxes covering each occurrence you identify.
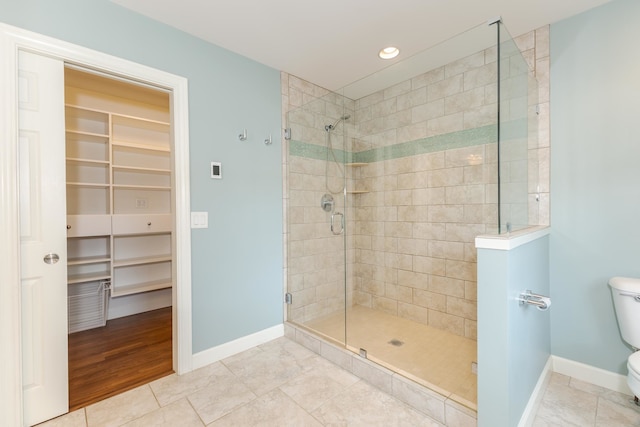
[550,0,640,375]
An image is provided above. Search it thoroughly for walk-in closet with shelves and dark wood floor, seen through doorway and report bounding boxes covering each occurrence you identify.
[65,66,175,409]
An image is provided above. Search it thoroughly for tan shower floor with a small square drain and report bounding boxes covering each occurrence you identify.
[305,306,478,409]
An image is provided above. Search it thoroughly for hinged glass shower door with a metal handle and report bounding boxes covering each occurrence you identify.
[285,87,352,345]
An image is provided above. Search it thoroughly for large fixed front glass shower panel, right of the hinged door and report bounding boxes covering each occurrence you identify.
[344,20,498,404]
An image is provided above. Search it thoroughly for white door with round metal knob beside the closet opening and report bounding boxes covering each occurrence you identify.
[18,51,69,425]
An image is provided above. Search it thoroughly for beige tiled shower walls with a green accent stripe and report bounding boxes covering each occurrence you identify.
[282,27,549,338]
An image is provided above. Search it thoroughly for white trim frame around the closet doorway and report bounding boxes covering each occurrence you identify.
[0,23,193,425]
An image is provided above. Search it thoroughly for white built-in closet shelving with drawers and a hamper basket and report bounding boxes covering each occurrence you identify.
[65,70,174,332]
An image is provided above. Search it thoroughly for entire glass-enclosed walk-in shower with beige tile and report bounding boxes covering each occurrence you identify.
[284,22,537,409]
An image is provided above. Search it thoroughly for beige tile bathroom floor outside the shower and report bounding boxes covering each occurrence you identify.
[40,338,640,427]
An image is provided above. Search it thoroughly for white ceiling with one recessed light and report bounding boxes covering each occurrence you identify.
[112,0,611,90]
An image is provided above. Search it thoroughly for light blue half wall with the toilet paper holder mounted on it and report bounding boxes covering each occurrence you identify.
[478,236,555,427]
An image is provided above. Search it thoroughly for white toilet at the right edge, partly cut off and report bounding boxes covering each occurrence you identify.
[609,277,640,403]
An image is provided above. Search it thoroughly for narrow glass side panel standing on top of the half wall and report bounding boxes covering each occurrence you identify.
[498,23,538,233]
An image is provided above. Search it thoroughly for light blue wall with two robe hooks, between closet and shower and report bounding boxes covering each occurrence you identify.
[0,0,283,353]
